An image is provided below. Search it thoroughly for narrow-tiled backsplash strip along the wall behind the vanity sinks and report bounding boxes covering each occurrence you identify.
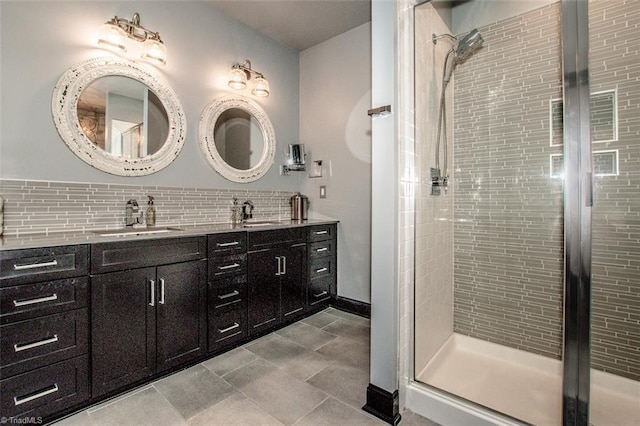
[0,179,293,236]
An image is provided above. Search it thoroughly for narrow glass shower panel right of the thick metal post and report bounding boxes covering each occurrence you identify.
[589,0,640,426]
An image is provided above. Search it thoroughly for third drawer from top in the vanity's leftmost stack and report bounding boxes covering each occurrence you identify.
[0,308,89,377]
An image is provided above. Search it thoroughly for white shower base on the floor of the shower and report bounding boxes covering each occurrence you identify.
[409,334,640,426]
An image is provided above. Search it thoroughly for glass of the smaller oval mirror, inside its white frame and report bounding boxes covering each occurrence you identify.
[213,108,264,170]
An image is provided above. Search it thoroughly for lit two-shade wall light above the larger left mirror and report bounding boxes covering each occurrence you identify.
[98,13,167,65]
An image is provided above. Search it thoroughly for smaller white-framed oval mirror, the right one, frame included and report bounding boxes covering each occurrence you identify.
[198,96,276,183]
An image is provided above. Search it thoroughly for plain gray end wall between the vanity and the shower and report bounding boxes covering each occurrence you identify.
[300,23,371,303]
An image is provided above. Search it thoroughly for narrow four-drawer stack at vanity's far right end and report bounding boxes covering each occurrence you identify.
[307,224,338,306]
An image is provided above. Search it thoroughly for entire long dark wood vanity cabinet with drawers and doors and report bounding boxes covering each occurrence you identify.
[0,224,337,421]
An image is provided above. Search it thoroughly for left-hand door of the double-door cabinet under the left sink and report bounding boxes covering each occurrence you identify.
[91,268,157,397]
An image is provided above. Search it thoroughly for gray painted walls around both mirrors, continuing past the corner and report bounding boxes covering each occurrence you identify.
[0,0,371,303]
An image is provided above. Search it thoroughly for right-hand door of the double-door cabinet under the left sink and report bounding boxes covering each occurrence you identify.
[157,260,207,371]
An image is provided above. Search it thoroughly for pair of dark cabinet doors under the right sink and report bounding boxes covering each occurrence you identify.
[248,228,307,335]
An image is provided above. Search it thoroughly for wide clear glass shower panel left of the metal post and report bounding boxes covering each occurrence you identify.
[414,0,565,425]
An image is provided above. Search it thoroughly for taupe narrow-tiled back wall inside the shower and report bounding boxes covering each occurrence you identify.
[454,0,640,380]
